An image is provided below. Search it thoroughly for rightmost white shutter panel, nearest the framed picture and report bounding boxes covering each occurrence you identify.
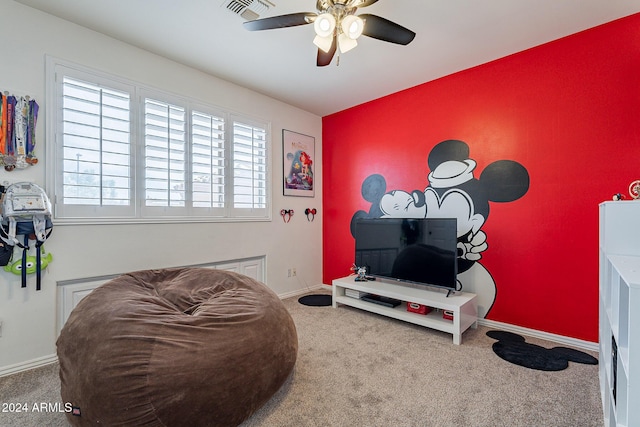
[233,120,268,216]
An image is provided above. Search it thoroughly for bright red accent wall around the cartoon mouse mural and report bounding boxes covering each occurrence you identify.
[322,14,640,342]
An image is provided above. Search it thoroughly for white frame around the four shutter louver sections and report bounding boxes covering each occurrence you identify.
[46,57,273,224]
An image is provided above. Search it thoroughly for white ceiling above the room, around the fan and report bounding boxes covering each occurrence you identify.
[16,0,640,116]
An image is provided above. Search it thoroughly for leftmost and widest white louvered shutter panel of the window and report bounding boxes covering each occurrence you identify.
[56,77,133,216]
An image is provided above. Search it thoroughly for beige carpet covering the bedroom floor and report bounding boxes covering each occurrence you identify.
[0,290,603,427]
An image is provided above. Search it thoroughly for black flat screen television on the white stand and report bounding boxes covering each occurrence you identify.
[354,218,459,295]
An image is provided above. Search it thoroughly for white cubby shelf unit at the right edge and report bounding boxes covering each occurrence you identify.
[599,201,640,427]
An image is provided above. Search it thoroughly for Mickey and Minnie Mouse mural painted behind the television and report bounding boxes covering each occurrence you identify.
[351,140,529,318]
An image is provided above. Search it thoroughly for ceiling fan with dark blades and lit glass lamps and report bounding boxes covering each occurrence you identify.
[243,0,416,67]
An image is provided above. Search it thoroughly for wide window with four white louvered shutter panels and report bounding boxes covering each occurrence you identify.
[47,62,270,221]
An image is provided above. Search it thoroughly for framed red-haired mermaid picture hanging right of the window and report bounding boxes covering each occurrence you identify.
[282,129,316,197]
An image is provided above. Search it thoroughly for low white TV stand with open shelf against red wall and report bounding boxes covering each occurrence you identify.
[332,275,478,344]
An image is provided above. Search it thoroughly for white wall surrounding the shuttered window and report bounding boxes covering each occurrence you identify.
[0,0,322,374]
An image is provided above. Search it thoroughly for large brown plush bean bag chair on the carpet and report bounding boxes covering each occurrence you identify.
[57,268,298,426]
